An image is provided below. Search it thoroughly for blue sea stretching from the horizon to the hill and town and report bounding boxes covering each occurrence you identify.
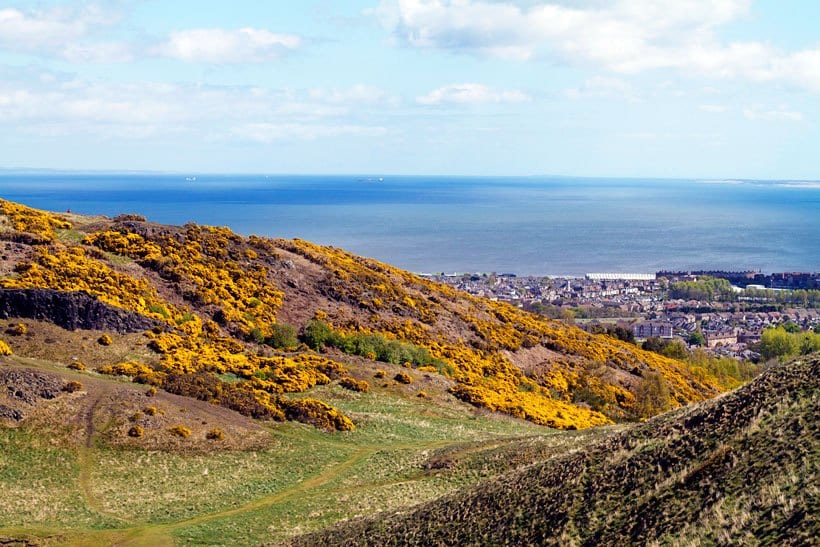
[0,172,820,276]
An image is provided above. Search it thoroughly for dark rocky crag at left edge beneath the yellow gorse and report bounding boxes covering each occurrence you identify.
[0,289,158,333]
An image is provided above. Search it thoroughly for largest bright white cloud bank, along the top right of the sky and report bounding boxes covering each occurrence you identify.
[374,0,820,91]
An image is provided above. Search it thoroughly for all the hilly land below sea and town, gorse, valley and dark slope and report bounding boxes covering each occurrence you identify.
[0,200,818,546]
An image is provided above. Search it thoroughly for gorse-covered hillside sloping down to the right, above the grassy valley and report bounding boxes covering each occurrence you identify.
[0,197,728,430]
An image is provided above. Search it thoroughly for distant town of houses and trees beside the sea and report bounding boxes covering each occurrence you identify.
[424,271,820,360]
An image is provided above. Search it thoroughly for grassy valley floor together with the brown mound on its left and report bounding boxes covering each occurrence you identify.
[0,354,596,546]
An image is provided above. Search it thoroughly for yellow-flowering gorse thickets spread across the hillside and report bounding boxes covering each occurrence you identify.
[0,200,725,429]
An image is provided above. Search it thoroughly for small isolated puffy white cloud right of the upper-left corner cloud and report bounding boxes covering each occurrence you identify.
[157,28,302,63]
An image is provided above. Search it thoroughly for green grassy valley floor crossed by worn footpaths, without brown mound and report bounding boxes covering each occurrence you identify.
[0,370,556,545]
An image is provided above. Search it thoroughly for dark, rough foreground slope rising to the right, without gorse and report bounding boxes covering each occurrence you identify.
[290,354,820,545]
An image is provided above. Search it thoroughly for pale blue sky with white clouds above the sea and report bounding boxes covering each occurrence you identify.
[0,0,820,180]
